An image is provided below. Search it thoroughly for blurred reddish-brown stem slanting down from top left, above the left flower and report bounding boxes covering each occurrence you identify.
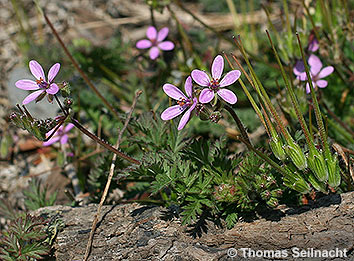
[43,12,121,124]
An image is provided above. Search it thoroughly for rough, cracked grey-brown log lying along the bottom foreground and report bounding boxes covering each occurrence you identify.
[36,192,354,261]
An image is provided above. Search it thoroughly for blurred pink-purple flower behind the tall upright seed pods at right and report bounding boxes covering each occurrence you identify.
[293,54,334,93]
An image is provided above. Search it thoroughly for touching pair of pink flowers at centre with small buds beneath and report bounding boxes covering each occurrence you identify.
[161,55,241,130]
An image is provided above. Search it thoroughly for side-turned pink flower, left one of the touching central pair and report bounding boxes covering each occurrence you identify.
[161,76,198,130]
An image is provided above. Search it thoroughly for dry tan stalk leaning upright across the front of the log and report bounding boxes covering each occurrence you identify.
[84,90,142,261]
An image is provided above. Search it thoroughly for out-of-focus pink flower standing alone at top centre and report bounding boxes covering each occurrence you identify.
[136,26,175,60]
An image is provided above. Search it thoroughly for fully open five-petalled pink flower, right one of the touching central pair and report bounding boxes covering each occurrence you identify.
[191,55,241,104]
